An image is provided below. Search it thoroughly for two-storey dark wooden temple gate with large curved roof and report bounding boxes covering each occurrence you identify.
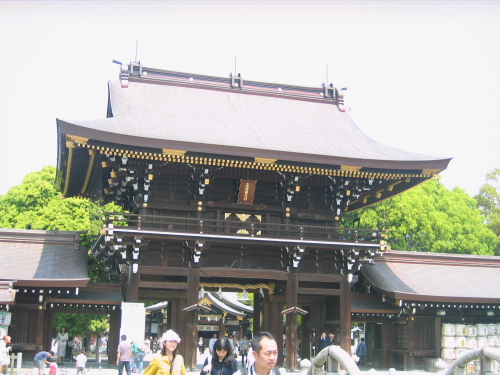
[53,62,450,369]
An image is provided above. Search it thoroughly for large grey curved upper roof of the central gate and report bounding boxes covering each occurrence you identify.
[58,68,450,171]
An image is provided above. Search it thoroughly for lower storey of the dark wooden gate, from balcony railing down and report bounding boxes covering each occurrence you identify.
[111,213,380,369]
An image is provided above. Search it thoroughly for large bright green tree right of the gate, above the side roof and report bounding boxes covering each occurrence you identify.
[344,180,497,255]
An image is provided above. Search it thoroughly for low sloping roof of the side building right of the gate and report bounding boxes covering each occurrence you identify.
[362,251,500,303]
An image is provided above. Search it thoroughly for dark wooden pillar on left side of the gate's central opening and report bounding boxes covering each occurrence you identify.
[184,267,200,371]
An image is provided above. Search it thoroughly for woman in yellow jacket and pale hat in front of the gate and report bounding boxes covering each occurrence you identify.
[144,329,186,375]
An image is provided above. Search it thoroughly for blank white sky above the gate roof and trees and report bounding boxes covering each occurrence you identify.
[0,0,500,195]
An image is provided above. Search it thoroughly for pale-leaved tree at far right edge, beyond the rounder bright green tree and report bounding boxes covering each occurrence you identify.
[474,168,500,255]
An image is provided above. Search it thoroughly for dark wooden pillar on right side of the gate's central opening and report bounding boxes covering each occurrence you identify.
[285,270,299,371]
